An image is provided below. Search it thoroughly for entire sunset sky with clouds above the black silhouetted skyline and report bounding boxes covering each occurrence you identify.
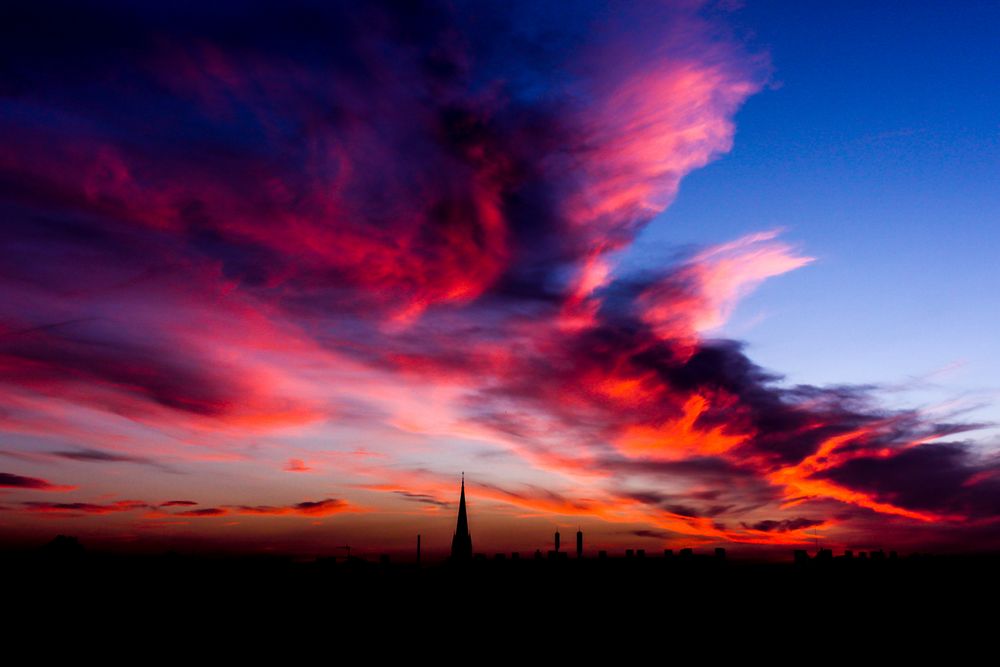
[0,0,1000,558]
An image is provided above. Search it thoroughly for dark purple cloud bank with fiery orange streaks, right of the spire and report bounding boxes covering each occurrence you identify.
[454,264,1000,532]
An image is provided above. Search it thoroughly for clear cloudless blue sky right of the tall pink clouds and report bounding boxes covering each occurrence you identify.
[637,2,1000,436]
